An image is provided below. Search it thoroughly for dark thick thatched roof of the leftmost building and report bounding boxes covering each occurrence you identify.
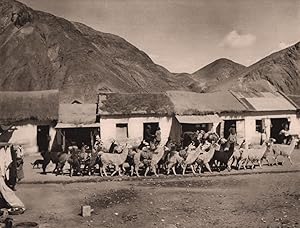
[0,90,59,124]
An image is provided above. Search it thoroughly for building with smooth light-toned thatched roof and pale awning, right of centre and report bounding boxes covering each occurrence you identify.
[167,91,247,141]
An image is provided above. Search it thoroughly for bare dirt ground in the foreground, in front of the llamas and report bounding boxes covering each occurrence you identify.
[10,173,300,228]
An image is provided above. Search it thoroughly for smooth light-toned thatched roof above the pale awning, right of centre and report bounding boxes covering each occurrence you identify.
[167,91,246,115]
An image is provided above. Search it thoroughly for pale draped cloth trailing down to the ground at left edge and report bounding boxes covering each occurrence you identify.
[0,146,25,214]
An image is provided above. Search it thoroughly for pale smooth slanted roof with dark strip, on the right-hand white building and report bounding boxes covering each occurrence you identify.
[231,91,296,111]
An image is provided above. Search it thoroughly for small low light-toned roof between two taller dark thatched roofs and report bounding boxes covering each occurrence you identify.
[59,104,97,125]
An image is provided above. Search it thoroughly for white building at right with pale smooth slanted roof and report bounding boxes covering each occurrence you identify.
[229,91,300,144]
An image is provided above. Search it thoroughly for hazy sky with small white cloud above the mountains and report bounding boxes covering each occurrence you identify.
[21,0,300,73]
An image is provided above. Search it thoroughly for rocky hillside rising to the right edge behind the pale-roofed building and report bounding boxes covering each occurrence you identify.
[207,42,300,94]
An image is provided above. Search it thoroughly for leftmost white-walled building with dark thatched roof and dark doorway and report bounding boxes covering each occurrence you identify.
[0,90,59,153]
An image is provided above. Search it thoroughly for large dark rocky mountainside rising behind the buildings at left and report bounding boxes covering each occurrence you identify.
[0,0,190,102]
